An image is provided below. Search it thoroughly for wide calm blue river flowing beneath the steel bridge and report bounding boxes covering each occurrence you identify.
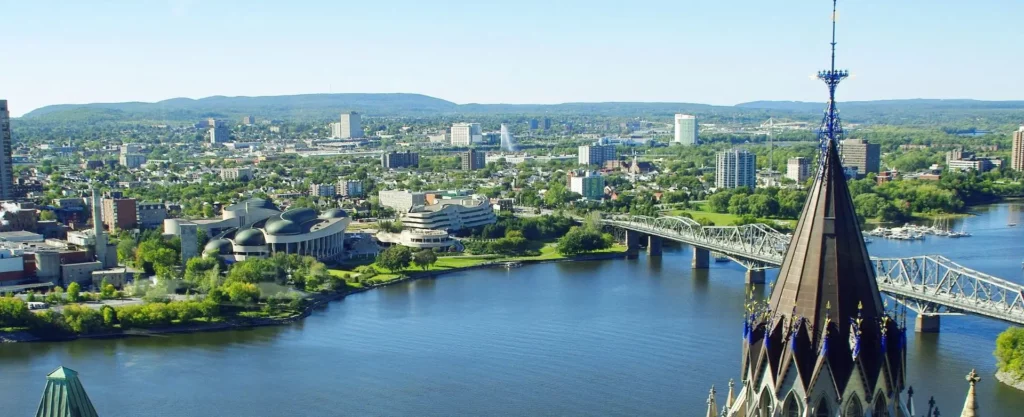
[0,204,1024,417]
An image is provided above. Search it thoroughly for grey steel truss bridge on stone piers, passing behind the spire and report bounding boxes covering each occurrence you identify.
[601,215,1024,331]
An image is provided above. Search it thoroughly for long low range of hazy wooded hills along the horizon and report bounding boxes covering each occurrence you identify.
[24,93,1024,127]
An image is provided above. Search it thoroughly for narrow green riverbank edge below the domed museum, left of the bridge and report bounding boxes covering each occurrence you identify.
[0,248,627,343]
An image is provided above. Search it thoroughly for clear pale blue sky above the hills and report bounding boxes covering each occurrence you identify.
[0,0,1024,116]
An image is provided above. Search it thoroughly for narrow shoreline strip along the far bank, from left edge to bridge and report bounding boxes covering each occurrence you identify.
[0,252,628,344]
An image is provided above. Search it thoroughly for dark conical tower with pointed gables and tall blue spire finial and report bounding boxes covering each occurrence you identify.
[727,0,909,417]
